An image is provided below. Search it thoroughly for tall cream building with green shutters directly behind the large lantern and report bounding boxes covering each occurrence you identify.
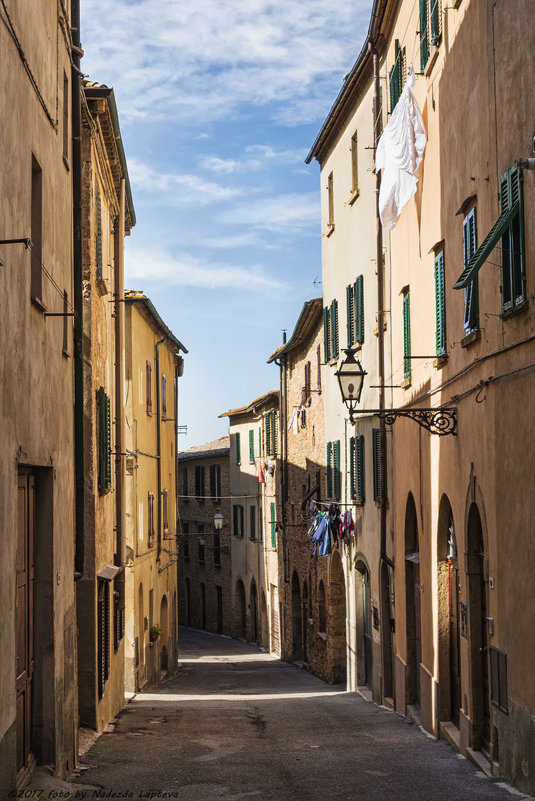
[307,21,394,705]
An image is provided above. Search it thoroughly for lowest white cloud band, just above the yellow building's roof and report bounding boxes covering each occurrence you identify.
[125,246,284,293]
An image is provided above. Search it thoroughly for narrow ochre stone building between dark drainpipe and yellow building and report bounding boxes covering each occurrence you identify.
[76,84,135,731]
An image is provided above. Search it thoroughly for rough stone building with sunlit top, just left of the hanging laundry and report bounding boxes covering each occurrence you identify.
[268,298,346,682]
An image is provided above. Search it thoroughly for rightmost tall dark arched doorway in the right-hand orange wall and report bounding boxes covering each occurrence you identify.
[467,503,490,753]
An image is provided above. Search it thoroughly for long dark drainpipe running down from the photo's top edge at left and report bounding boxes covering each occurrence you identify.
[71,0,85,581]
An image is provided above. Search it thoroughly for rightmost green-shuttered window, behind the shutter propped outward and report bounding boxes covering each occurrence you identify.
[500,168,526,311]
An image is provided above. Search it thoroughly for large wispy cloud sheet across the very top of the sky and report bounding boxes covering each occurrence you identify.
[82,0,371,125]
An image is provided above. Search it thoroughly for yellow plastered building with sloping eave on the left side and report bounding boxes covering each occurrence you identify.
[124,290,187,692]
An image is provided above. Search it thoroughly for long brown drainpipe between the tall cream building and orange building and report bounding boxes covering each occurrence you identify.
[370,44,394,567]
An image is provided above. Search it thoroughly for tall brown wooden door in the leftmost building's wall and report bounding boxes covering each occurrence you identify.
[15,473,35,785]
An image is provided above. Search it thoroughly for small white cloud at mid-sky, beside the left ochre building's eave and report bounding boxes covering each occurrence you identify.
[128,158,243,206]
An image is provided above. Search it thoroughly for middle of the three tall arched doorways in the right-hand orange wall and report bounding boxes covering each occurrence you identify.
[437,495,461,727]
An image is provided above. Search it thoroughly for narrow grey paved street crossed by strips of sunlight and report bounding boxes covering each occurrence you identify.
[49,629,519,801]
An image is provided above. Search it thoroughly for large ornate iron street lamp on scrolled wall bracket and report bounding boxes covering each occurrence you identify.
[335,348,457,437]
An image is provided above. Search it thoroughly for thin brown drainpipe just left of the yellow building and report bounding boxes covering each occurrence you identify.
[114,178,126,609]
